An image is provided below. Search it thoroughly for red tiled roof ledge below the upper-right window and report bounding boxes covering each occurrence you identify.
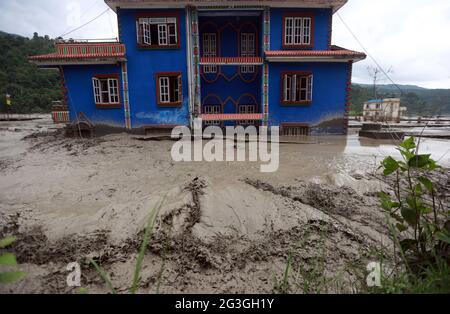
[266,46,366,59]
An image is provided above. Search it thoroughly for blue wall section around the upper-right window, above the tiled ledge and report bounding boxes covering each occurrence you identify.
[270,8,332,50]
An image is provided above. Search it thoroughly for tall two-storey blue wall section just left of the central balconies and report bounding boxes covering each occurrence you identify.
[118,9,189,128]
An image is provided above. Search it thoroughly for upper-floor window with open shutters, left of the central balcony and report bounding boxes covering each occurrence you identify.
[136,16,179,47]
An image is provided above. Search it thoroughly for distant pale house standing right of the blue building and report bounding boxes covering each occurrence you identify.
[363,98,406,123]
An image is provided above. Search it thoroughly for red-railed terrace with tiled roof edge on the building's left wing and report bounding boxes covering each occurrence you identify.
[29,43,125,62]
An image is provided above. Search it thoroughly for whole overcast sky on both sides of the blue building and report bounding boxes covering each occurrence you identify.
[0,0,450,88]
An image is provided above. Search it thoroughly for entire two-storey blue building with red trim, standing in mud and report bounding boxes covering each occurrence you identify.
[30,0,366,135]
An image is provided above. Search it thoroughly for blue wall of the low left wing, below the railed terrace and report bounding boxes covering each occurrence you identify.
[64,65,125,127]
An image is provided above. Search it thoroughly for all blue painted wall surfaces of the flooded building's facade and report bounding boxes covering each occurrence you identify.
[58,9,349,133]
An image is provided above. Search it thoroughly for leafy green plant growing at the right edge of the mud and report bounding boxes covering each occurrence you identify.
[379,137,450,275]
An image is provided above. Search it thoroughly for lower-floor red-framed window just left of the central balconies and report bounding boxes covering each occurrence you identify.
[156,73,183,106]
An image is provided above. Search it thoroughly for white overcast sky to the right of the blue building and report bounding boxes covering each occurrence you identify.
[333,0,450,88]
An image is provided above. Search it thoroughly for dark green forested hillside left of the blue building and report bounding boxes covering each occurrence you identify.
[0,32,61,113]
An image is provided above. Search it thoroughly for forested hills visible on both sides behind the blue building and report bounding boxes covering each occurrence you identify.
[0,31,450,115]
